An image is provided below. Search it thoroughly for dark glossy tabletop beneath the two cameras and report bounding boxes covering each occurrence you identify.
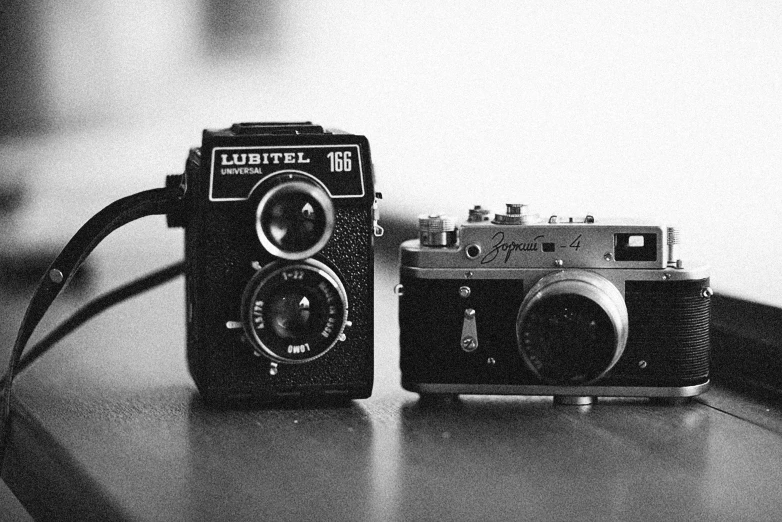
[3,256,782,520]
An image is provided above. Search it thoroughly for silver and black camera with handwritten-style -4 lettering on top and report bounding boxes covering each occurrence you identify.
[397,204,712,404]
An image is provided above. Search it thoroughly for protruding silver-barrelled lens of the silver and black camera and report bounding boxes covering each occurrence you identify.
[516,270,628,385]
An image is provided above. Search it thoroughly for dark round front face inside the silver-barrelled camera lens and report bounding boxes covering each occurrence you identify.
[522,295,616,385]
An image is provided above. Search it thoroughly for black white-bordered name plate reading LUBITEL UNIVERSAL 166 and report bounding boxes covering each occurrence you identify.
[209,145,365,201]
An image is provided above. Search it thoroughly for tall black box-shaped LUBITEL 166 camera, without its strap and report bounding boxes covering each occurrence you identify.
[168,122,382,402]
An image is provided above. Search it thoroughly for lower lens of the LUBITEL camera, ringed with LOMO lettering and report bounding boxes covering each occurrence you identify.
[242,259,348,363]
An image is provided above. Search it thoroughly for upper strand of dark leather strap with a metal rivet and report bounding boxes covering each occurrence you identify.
[0,186,185,466]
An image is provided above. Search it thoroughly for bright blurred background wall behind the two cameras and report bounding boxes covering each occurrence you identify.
[0,0,782,306]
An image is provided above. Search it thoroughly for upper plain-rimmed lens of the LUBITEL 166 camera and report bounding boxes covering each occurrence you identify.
[256,179,334,260]
